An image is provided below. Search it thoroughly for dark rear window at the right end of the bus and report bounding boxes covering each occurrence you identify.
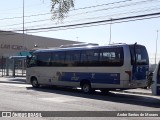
[129,44,149,65]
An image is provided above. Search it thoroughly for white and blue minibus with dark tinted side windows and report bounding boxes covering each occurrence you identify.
[26,43,149,93]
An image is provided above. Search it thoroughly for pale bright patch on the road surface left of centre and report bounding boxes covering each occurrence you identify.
[39,97,76,103]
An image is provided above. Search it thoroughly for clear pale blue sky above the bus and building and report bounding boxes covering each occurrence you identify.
[0,0,160,63]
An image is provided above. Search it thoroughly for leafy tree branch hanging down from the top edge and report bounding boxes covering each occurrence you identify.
[51,0,74,20]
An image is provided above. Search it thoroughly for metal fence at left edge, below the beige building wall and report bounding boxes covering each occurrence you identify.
[0,57,26,77]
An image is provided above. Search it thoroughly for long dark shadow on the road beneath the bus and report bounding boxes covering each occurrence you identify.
[27,86,160,108]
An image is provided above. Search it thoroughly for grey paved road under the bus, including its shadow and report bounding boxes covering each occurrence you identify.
[0,78,160,120]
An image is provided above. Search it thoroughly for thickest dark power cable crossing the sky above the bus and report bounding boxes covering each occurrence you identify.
[0,12,160,35]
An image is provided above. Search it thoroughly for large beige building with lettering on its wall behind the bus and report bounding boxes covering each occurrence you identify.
[0,31,77,58]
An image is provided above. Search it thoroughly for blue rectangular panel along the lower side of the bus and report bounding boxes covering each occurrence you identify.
[59,72,120,84]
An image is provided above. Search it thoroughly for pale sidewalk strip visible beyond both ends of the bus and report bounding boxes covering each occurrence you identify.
[0,77,152,95]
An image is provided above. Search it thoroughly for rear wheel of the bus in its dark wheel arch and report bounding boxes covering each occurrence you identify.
[80,80,92,93]
